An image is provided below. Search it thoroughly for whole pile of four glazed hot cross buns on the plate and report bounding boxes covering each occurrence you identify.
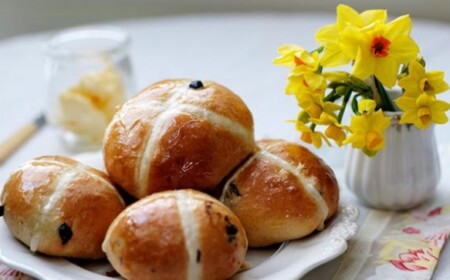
[1,79,339,279]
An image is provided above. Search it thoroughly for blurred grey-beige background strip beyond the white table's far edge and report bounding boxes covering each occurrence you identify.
[0,0,450,38]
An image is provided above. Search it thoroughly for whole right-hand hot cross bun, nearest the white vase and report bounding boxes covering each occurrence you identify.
[222,140,339,247]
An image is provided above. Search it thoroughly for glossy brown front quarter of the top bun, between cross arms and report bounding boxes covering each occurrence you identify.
[148,112,250,193]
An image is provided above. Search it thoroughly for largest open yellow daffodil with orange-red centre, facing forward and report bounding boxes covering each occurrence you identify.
[340,15,419,87]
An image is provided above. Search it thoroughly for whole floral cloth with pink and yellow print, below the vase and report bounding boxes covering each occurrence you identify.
[333,205,450,280]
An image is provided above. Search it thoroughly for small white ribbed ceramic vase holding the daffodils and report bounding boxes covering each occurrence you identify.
[345,112,440,210]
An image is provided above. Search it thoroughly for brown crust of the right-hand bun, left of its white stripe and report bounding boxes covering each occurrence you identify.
[227,159,320,247]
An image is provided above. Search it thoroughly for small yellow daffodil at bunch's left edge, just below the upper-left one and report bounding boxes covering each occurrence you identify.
[286,73,327,95]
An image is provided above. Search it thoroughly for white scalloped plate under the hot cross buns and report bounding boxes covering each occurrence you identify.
[0,154,359,280]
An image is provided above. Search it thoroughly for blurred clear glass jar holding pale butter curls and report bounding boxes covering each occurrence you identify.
[45,26,135,151]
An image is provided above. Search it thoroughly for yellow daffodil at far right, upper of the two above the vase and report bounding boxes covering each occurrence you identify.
[398,60,449,98]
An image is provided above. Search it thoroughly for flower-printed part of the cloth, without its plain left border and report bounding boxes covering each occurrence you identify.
[354,205,450,280]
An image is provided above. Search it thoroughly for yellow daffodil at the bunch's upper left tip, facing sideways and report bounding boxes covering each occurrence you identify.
[273,45,319,75]
